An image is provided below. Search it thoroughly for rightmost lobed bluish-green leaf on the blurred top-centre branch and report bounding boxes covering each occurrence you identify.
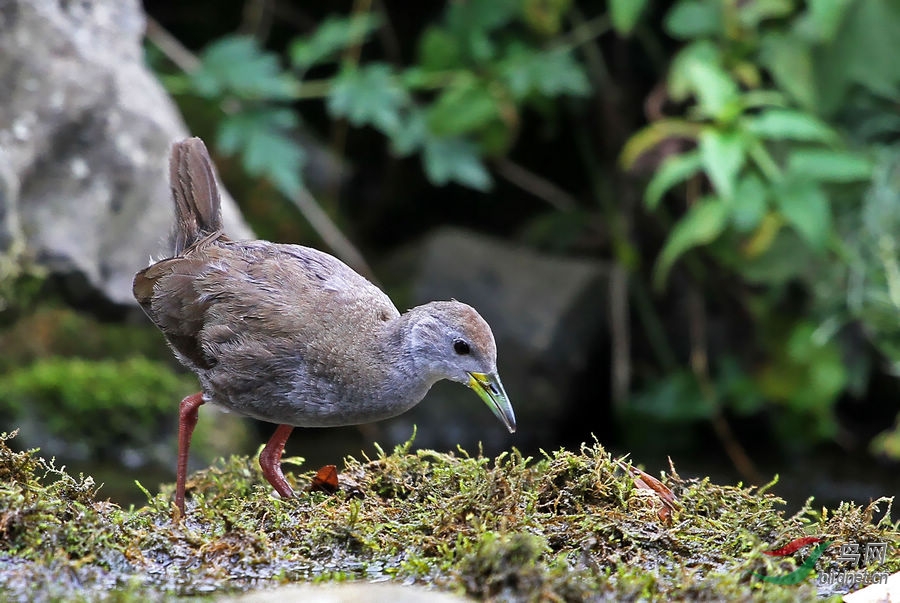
[499,45,591,100]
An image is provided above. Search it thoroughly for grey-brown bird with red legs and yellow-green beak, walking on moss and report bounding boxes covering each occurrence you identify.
[133,138,516,517]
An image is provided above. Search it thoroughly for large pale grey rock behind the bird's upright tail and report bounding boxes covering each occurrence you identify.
[0,0,251,305]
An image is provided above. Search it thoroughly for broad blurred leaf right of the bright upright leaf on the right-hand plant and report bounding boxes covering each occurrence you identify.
[760,33,818,110]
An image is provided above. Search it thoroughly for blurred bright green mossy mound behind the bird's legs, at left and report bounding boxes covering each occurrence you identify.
[0,356,248,472]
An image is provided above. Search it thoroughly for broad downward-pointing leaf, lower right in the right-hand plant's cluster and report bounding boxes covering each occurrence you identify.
[774,180,832,251]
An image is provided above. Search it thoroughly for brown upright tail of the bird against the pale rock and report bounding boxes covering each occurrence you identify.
[169,138,222,256]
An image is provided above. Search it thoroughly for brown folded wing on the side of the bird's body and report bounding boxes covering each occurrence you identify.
[134,241,399,369]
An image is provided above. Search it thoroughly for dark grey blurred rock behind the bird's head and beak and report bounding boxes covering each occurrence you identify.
[384,229,609,453]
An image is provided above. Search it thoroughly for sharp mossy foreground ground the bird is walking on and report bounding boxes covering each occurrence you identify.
[0,436,900,601]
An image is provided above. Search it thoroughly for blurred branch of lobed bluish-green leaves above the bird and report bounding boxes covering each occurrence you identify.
[164,0,591,197]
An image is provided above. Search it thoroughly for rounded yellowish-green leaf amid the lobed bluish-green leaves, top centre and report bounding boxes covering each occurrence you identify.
[428,77,500,138]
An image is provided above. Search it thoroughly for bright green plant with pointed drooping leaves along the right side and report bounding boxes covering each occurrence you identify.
[621,0,900,452]
